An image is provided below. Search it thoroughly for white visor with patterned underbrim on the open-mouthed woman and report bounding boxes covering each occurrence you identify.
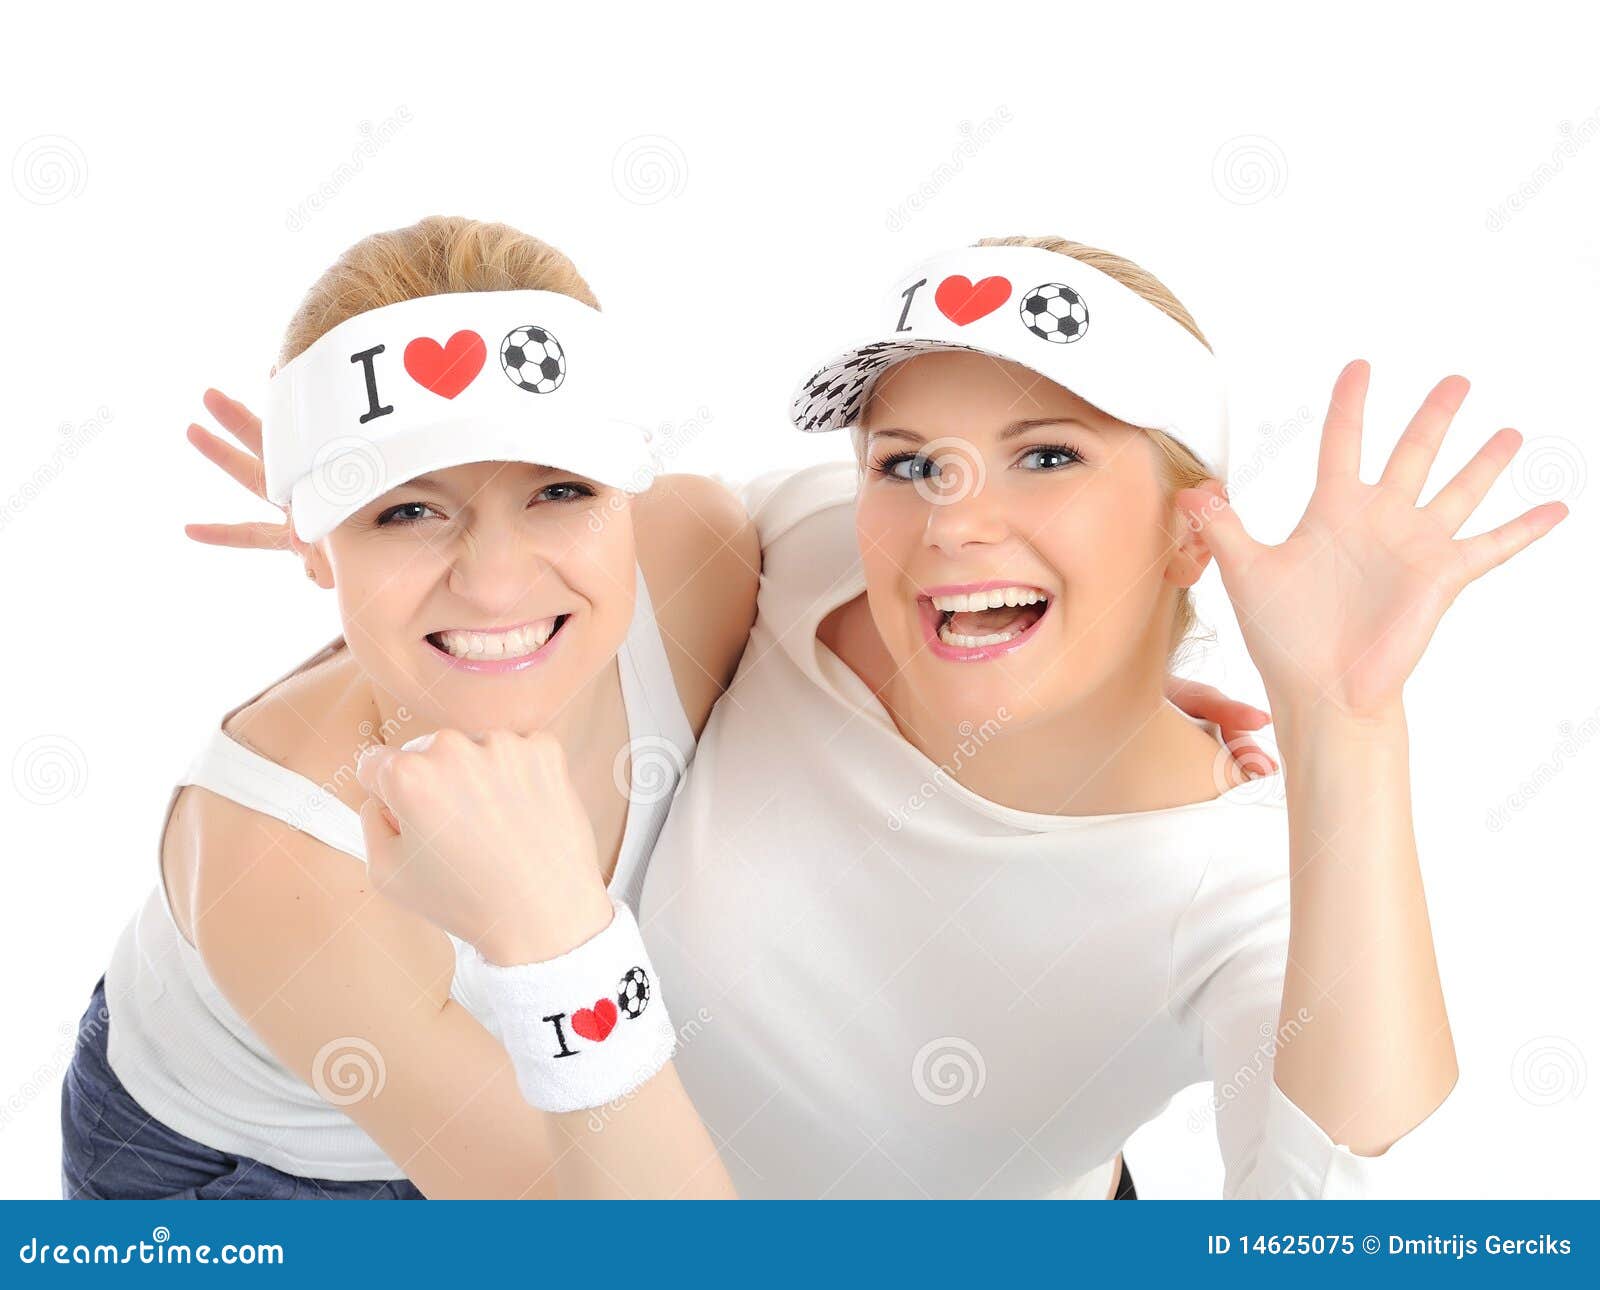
[790,246,1227,479]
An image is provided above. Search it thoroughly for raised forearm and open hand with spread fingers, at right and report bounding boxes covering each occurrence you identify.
[1179,362,1566,1156]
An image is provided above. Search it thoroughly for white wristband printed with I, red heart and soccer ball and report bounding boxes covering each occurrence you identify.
[478,896,677,1111]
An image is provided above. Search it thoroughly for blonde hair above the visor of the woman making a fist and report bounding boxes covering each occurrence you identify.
[278,214,600,367]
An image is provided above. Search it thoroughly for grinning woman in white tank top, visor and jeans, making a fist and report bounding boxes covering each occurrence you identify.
[62,218,757,1199]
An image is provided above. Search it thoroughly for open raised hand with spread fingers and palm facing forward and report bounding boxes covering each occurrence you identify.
[1178,360,1566,723]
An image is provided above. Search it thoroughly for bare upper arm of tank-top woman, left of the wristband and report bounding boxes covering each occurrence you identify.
[189,789,555,1199]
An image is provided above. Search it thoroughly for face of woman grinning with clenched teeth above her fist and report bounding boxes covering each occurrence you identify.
[318,461,635,730]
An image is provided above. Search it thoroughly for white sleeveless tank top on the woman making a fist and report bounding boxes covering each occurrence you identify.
[106,573,694,1180]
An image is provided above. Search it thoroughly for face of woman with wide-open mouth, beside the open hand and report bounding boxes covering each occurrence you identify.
[856,351,1205,733]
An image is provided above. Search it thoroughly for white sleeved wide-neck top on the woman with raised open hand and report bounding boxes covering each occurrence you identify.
[638,463,1440,1199]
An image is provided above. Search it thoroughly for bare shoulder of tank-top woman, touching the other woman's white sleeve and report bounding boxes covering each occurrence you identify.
[634,475,762,733]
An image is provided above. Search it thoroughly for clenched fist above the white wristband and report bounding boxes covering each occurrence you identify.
[355,730,611,963]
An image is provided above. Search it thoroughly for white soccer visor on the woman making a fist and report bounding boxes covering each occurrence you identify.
[261,291,653,541]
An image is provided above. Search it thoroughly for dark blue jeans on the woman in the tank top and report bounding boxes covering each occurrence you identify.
[61,976,424,1200]
